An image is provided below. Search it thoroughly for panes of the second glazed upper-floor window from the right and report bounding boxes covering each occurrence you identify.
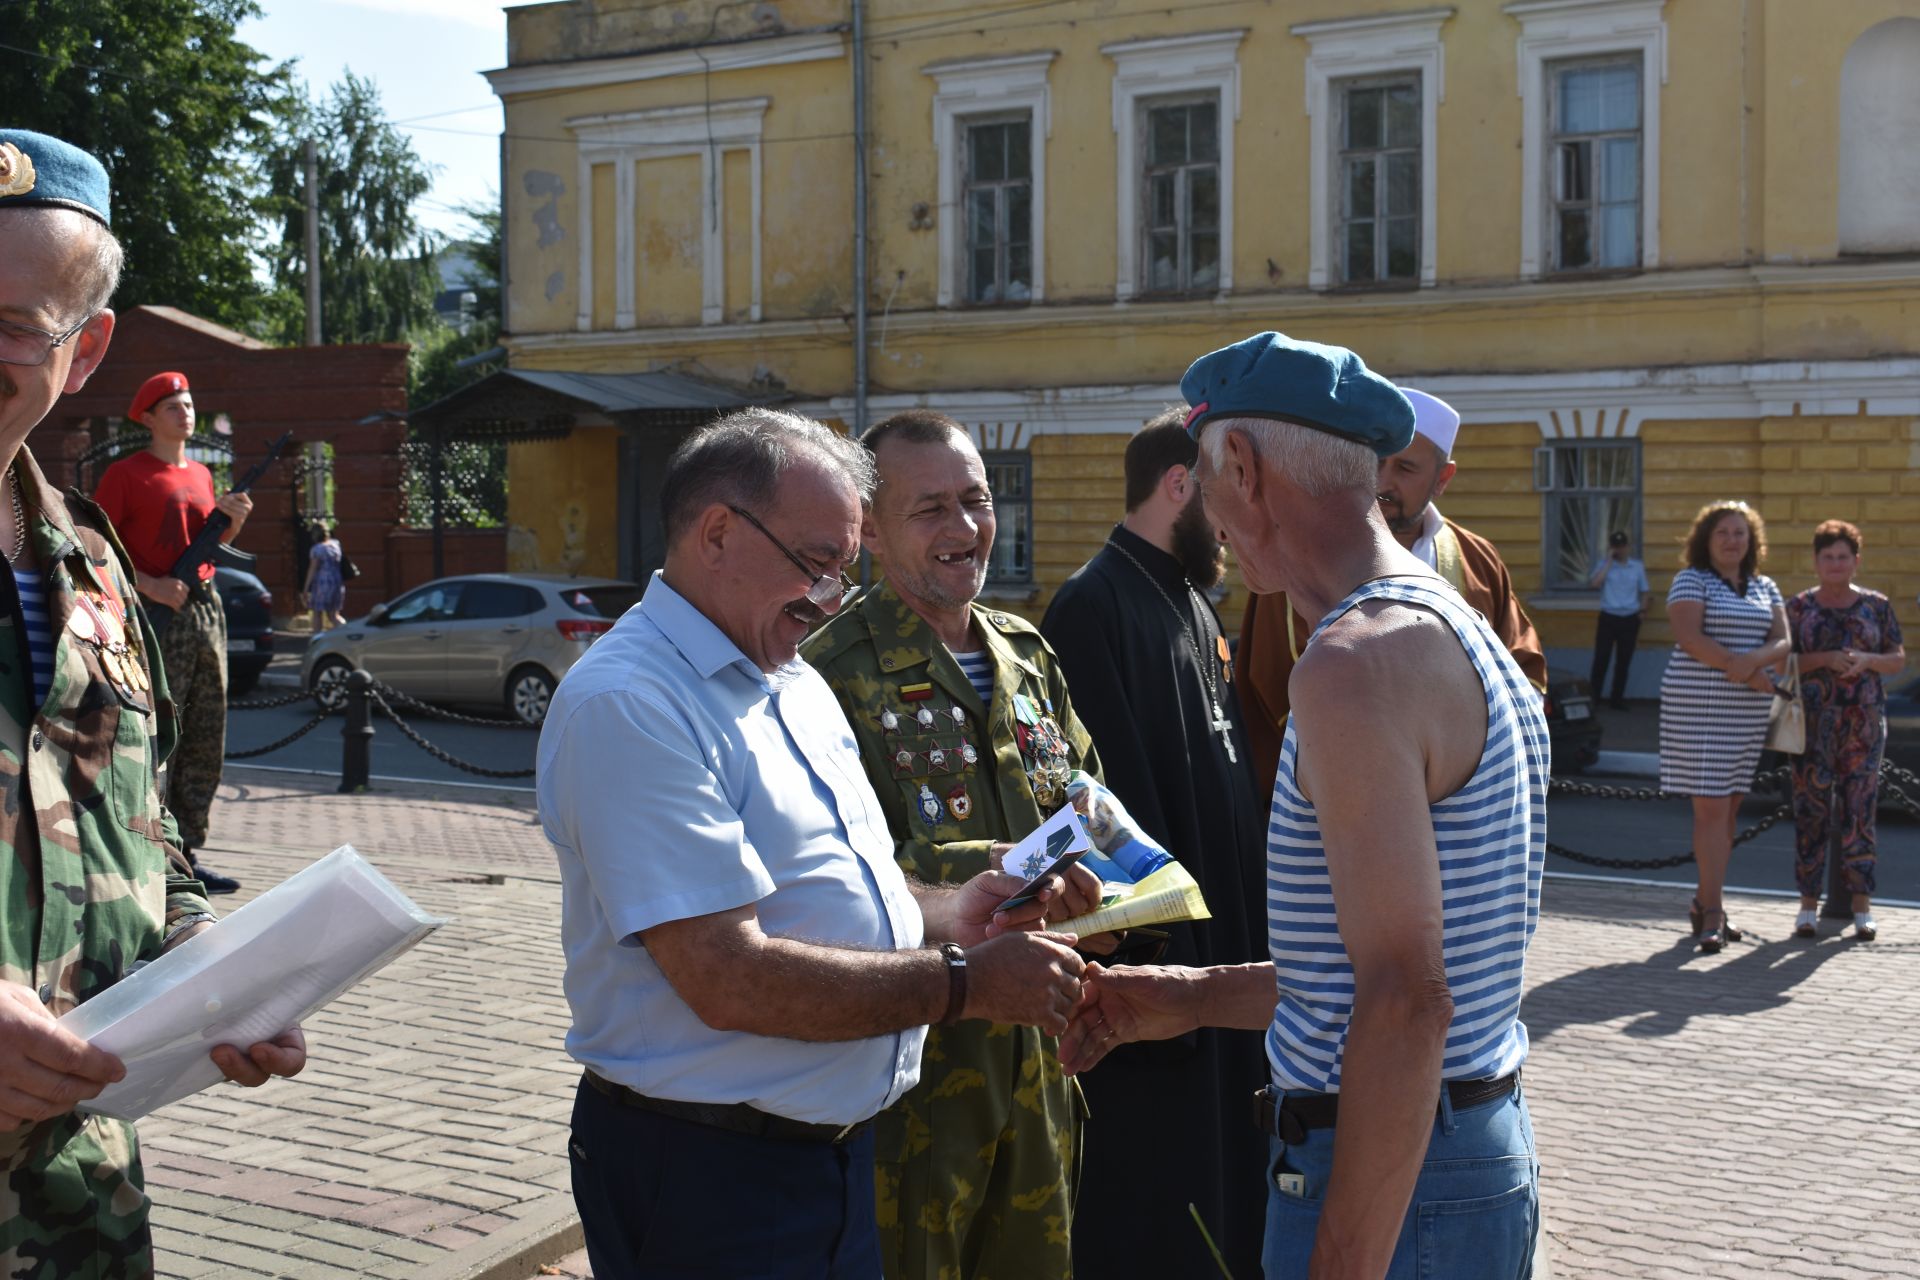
[1336,77,1421,284]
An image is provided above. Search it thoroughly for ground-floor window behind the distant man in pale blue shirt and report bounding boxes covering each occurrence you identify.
[1534,439,1640,591]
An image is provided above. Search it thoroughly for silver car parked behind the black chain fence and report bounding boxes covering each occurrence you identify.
[300,574,641,723]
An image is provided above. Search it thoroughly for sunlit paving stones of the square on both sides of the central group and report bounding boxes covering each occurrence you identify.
[140,768,1920,1280]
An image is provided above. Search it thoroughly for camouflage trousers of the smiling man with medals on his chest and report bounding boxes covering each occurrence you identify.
[874,1023,1087,1280]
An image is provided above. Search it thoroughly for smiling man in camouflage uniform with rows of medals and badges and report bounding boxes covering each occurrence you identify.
[801,411,1098,1280]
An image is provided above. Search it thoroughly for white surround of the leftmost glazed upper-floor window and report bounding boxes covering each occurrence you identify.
[922,50,1058,307]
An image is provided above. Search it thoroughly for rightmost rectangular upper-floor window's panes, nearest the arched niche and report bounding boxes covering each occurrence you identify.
[1548,56,1642,271]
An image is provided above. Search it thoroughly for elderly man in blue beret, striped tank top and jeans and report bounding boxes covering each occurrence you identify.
[1060,332,1548,1280]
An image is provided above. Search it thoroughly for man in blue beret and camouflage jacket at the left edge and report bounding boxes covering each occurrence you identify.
[0,129,305,1280]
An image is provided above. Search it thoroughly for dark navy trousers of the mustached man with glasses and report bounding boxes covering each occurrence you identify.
[568,1080,879,1280]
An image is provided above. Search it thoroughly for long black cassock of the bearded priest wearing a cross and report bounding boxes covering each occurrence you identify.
[1041,528,1269,1280]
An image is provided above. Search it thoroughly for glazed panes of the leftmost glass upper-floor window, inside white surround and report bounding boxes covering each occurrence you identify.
[962,117,1033,303]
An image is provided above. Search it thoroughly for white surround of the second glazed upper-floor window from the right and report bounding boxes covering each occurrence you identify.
[1288,8,1453,290]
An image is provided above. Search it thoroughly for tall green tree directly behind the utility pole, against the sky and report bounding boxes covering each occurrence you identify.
[267,71,440,344]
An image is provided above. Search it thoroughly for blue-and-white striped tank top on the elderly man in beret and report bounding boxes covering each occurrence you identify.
[1267,578,1548,1094]
